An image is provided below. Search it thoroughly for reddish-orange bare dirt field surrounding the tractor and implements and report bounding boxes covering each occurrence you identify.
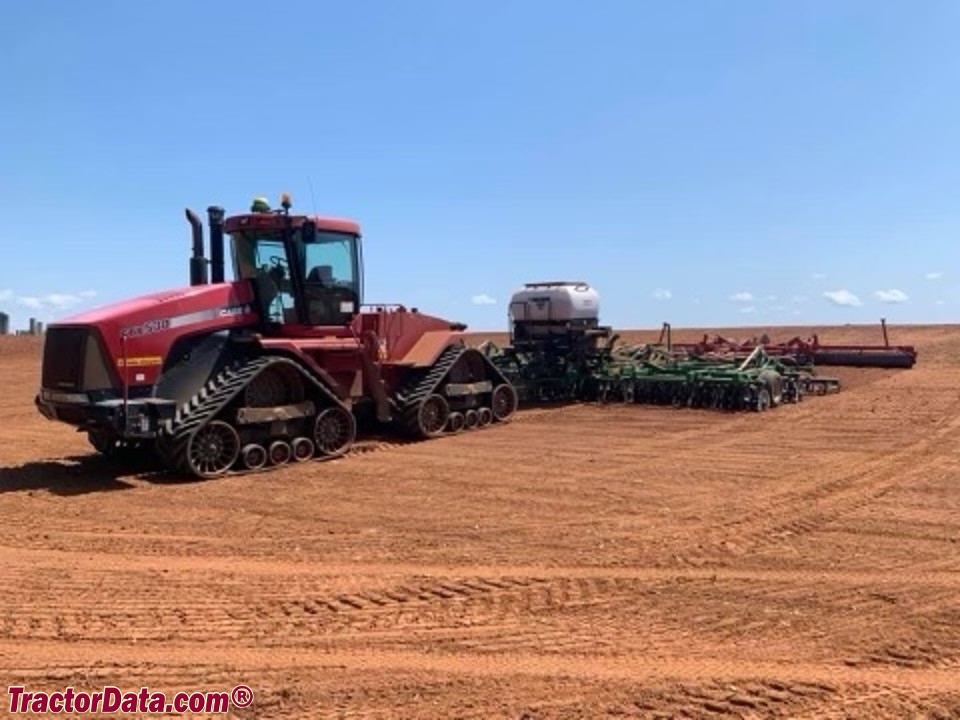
[0,326,960,719]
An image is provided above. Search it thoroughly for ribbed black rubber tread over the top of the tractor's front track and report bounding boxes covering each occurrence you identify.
[160,357,346,472]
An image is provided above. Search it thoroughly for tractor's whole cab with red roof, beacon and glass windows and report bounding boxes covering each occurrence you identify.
[223,195,363,329]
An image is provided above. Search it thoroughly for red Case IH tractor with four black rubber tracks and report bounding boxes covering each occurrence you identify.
[36,195,517,478]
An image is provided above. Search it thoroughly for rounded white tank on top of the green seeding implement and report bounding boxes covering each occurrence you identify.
[510,281,600,325]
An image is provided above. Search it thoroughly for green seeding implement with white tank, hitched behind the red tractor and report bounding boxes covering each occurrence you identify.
[481,282,840,411]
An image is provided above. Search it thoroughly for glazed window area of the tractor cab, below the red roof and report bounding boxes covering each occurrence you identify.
[233,230,362,326]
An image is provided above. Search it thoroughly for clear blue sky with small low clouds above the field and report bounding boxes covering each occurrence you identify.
[0,0,960,329]
